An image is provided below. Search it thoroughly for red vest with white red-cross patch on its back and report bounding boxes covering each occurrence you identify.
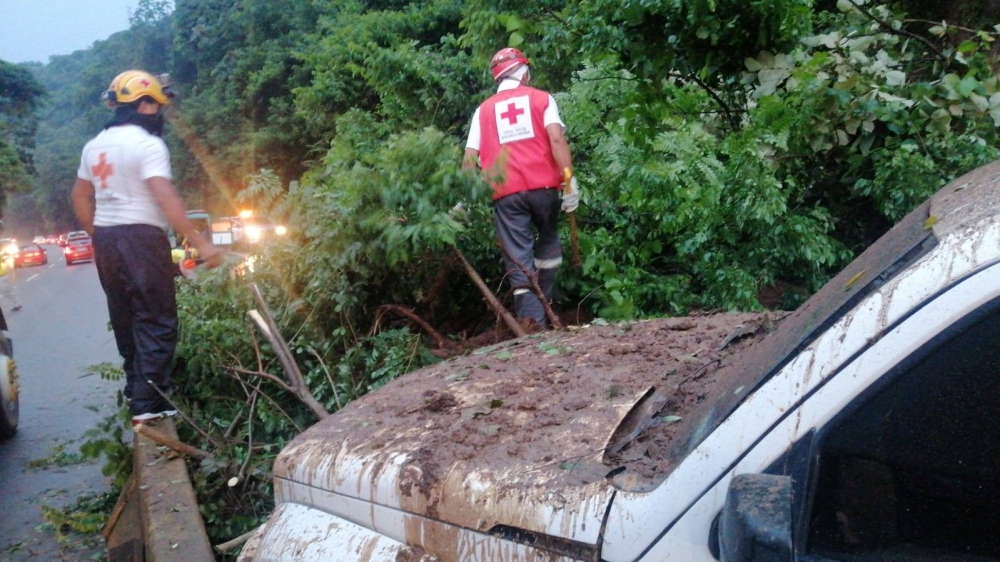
[479,86,562,201]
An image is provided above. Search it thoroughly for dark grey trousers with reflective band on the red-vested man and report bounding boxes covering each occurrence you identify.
[493,188,562,326]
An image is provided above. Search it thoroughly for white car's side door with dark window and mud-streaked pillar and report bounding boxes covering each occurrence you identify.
[638,259,1000,561]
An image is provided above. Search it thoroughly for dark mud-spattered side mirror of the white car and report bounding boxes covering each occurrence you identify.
[718,474,794,562]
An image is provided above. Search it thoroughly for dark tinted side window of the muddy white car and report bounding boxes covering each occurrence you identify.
[806,304,1000,561]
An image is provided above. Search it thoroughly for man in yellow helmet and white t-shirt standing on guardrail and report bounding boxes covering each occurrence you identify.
[72,70,223,424]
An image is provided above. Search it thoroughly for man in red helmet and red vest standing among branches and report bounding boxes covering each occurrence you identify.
[462,47,580,326]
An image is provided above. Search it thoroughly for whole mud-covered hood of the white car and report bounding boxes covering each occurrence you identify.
[274,315,772,545]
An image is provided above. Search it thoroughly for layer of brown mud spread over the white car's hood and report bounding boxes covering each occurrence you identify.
[292,313,784,495]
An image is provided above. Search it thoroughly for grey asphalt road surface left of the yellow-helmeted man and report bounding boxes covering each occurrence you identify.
[0,246,122,562]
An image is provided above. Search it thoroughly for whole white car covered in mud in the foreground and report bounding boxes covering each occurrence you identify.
[241,159,1000,562]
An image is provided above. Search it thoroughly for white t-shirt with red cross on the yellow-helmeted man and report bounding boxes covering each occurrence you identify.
[76,125,172,229]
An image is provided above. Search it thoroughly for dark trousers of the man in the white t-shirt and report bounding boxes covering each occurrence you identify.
[94,224,177,415]
